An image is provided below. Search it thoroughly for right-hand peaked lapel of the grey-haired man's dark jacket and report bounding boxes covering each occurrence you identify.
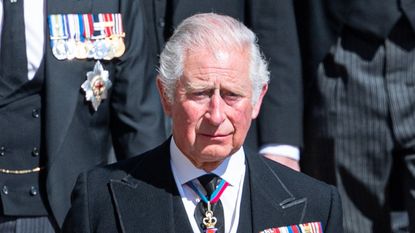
[246,154,307,232]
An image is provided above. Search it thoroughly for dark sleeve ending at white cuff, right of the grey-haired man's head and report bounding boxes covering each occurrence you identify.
[249,0,302,147]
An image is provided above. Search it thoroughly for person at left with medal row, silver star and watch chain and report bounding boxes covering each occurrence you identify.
[0,0,163,233]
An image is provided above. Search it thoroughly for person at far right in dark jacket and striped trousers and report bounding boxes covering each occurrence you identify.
[296,0,415,233]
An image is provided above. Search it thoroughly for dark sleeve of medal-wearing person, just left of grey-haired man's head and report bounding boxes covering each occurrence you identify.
[111,0,165,159]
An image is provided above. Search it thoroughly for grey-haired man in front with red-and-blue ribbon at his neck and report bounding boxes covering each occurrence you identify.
[64,13,342,233]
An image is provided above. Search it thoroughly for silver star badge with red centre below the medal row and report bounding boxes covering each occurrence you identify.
[81,61,112,111]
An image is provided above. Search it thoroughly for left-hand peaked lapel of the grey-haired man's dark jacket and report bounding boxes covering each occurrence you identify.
[110,140,192,233]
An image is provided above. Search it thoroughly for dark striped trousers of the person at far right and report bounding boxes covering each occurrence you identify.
[301,19,415,233]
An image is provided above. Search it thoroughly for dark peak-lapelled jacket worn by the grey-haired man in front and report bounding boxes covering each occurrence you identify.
[64,140,342,233]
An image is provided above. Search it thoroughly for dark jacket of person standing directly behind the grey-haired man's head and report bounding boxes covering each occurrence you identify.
[144,0,302,150]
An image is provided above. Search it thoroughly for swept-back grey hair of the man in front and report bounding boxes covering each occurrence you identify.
[158,13,269,104]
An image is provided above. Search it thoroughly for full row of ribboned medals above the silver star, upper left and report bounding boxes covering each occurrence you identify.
[48,13,125,60]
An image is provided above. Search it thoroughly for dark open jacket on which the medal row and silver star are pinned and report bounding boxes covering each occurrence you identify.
[43,0,164,227]
